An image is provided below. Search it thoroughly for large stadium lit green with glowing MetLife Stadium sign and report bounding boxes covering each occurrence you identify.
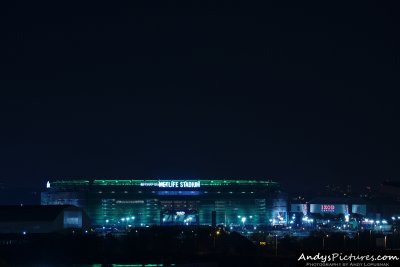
[41,180,287,227]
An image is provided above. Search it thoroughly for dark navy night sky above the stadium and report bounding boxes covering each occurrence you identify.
[0,1,400,197]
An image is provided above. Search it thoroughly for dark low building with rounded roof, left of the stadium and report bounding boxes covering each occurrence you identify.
[0,205,90,234]
